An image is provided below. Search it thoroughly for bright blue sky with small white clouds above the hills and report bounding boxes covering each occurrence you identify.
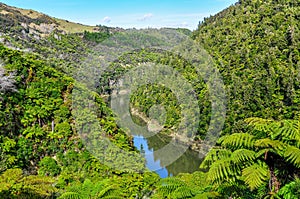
[1,0,237,30]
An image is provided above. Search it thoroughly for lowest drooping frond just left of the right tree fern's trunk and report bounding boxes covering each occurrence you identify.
[242,163,270,190]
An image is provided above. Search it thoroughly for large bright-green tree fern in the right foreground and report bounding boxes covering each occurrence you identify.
[200,118,300,192]
